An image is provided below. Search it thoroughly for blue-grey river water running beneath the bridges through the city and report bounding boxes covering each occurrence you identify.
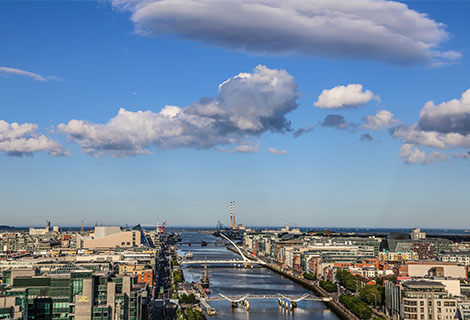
[178,232,339,320]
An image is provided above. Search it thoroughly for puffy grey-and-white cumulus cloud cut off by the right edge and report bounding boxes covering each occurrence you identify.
[390,89,470,163]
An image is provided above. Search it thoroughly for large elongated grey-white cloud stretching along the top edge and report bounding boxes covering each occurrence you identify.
[113,0,461,65]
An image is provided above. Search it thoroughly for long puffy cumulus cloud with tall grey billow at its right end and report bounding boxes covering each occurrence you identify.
[58,65,298,156]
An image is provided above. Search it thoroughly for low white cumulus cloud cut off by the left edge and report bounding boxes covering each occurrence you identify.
[0,120,68,156]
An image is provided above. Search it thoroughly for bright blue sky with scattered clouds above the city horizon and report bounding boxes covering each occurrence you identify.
[0,0,470,228]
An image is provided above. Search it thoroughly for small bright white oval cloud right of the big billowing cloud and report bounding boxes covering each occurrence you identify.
[314,84,374,109]
